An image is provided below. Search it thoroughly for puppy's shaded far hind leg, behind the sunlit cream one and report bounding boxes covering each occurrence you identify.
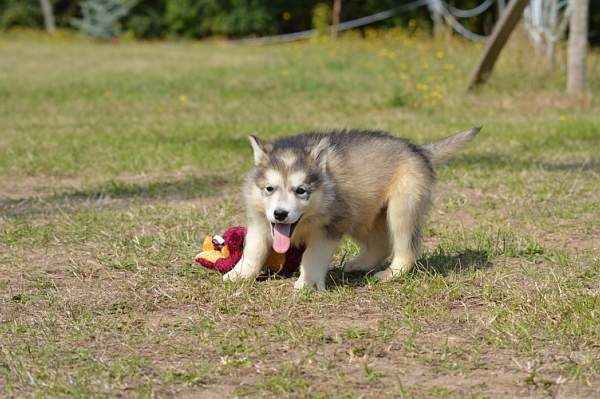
[344,213,391,273]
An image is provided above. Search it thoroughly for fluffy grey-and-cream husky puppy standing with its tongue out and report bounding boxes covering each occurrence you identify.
[224,128,480,289]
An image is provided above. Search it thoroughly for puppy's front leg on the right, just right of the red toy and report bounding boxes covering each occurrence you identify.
[294,232,339,290]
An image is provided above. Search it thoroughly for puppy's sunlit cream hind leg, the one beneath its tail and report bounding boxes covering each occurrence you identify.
[375,166,433,280]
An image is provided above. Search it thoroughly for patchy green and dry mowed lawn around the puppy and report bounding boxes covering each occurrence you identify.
[0,32,600,398]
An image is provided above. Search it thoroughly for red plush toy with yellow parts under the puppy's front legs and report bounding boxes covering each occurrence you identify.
[195,226,304,275]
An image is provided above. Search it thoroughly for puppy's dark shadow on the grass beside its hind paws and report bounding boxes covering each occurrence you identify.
[328,248,492,287]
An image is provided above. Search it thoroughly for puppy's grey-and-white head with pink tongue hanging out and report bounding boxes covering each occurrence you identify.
[246,136,327,253]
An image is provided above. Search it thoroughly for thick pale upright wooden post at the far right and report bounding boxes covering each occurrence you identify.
[567,0,589,94]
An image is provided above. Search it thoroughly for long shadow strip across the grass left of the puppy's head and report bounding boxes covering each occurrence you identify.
[0,175,229,217]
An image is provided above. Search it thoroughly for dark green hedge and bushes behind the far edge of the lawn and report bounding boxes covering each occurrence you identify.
[0,0,600,45]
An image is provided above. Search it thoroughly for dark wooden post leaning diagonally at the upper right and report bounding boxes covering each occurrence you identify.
[468,0,529,90]
